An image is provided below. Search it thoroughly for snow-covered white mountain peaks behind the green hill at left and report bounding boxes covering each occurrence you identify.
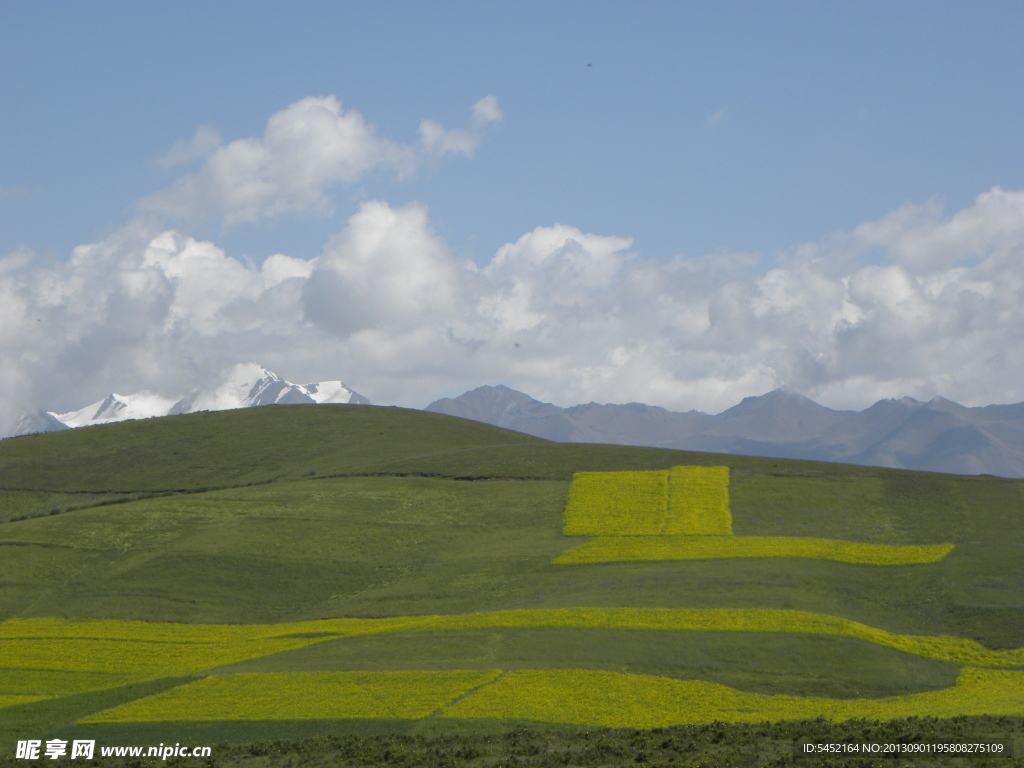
[43,362,370,434]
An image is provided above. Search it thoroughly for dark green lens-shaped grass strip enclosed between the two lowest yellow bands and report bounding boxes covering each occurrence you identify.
[208,627,962,698]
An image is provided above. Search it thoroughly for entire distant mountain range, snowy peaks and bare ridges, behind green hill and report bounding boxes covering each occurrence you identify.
[13,362,1024,477]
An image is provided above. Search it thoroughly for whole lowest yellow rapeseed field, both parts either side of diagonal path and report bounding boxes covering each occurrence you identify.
[81,668,1024,728]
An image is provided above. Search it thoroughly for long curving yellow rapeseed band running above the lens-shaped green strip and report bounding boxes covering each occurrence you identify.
[0,608,1024,695]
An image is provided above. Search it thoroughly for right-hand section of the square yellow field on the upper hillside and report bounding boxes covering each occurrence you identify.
[658,467,732,536]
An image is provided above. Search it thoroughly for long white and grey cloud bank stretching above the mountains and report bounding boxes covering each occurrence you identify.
[0,187,1024,428]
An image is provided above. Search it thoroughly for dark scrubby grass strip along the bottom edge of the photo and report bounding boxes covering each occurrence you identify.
[0,717,1022,768]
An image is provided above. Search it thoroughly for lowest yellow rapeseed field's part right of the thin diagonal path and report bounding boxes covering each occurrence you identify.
[441,668,1024,728]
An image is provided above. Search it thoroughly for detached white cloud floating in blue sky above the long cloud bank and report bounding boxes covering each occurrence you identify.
[136,96,501,226]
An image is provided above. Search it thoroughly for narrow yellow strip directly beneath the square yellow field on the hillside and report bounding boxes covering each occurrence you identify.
[552,536,953,565]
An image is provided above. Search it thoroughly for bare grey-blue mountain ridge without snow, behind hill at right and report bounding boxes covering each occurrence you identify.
[425,386,1024,477]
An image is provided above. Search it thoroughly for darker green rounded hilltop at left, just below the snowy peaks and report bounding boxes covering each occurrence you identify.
[0,406,543,494]
